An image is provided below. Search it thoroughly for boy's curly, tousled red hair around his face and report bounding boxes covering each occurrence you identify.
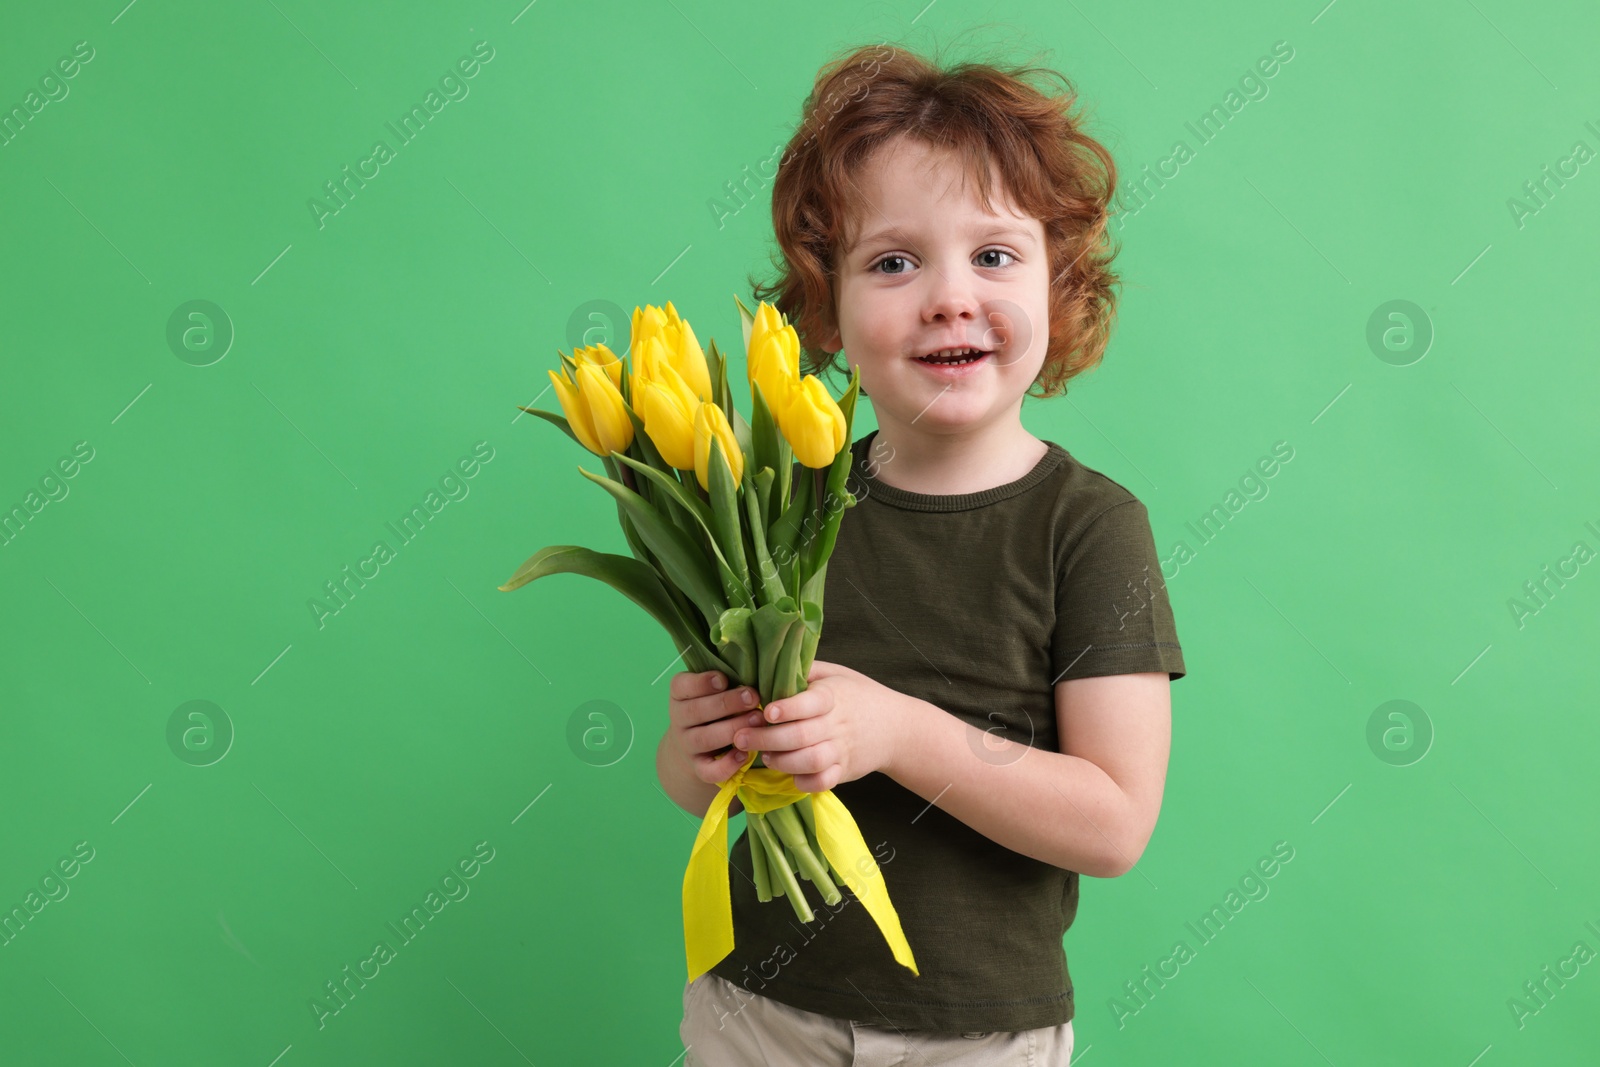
[752,43,1118,398]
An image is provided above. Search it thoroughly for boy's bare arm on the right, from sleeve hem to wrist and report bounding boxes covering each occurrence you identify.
[880,670,1171,878]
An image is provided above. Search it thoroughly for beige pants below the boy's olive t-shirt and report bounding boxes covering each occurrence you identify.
[678,971,1072,1067]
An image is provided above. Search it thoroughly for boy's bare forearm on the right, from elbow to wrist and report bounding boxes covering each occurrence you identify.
[882,694,1142,878]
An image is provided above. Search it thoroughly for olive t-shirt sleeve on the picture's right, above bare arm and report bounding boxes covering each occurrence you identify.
[1050,499,1186,686]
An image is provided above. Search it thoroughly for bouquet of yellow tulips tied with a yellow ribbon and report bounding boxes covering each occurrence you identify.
[501,298,917,981]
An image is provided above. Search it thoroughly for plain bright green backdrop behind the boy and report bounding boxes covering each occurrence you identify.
[0,0,1600,1067]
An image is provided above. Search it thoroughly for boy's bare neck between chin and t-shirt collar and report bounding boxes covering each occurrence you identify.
[867,421,1050,496]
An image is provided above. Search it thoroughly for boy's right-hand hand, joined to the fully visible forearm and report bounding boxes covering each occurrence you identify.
[733,659,907,793]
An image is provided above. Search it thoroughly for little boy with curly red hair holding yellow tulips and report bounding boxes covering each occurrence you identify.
[658,39,1184,1067]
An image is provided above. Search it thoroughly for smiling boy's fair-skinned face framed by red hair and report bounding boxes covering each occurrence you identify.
[822,136,1050,440]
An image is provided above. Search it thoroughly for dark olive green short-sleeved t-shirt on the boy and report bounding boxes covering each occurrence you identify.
[712,430,1184,1032]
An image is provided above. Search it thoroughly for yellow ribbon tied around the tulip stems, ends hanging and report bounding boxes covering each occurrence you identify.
[683,752,922,982]
